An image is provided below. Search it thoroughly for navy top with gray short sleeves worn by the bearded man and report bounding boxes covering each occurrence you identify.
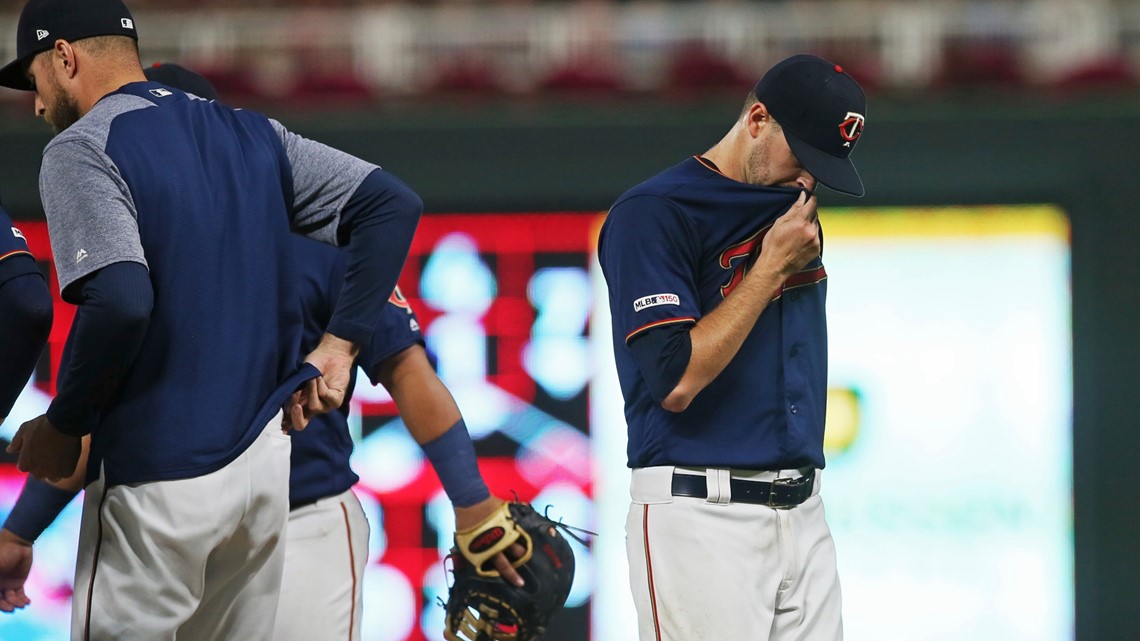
[40,82,376,485]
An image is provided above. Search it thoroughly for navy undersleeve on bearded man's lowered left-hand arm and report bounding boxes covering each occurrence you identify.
[47,262,154,436]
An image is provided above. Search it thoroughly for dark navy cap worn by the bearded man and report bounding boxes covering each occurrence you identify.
[0,0,139,91]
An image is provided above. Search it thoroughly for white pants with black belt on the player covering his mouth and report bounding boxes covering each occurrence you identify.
[626,466,842,641]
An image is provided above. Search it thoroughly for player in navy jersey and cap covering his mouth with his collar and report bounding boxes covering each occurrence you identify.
[599,55,866,641]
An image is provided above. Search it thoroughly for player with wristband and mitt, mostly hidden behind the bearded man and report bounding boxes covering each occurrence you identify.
[0,64,520,641]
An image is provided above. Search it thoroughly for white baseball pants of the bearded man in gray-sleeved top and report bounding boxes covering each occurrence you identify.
[72,414,291,641]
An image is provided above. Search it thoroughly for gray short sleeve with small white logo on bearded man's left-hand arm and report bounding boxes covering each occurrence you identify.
[40,138,147,291]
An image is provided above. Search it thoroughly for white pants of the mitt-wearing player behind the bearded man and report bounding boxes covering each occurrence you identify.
[274,489,368,641]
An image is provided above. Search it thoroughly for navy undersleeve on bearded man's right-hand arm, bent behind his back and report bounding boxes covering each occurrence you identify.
[328,170,423,344]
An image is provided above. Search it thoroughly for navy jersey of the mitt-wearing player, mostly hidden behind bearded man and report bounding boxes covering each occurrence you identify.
[290,236,423,508]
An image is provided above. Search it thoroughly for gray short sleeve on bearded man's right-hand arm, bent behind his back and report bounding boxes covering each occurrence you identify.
[269,119,380,245]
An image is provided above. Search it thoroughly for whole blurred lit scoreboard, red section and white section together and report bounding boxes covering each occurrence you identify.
[0,205,1074,641]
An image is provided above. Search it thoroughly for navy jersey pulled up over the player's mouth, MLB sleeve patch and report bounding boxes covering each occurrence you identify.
[599,159,828,470]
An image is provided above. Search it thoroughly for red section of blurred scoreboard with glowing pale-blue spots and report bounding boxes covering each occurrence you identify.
[0,213,599,641]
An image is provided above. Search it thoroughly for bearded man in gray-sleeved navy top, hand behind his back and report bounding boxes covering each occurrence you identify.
[0,0,422,640]
